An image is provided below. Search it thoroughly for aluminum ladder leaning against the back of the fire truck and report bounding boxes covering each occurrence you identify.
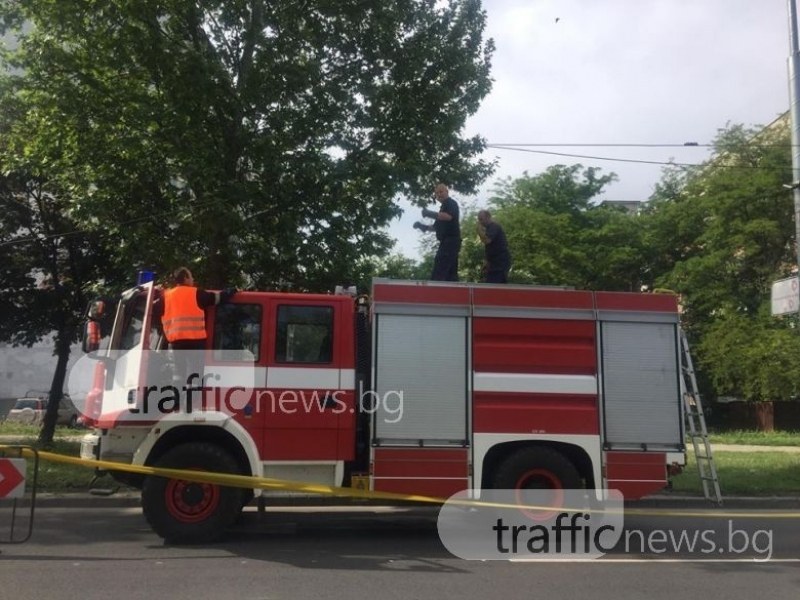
[680,329,722,506]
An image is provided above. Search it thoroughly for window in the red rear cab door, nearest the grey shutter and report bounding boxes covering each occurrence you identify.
[275,305,333,363]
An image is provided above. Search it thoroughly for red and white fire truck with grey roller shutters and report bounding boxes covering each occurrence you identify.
[81,280,685,541]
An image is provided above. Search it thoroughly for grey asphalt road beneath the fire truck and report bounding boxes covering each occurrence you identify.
[0,504,800,600]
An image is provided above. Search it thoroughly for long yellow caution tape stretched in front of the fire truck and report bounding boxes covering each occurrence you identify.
[6,445,800,519]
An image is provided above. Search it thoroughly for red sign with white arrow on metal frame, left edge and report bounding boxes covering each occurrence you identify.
[0,445,39,544]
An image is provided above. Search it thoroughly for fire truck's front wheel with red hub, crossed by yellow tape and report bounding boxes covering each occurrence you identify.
[142,442,244,544]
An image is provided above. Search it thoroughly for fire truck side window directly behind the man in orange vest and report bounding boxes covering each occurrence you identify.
[213,304,261,362]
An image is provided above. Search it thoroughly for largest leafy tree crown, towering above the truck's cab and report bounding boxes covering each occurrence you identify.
[0,0,493,289]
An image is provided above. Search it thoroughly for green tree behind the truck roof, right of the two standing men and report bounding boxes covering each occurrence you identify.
[472,165,646,291]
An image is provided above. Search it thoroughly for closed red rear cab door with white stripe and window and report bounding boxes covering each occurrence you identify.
[259,294,356,468]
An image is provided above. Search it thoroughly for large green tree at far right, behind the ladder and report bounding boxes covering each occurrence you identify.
[647,121,800,428]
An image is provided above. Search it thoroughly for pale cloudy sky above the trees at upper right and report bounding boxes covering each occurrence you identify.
[389,0,788,258]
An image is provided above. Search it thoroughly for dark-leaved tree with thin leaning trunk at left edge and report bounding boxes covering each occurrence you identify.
[0,173,126,445]
